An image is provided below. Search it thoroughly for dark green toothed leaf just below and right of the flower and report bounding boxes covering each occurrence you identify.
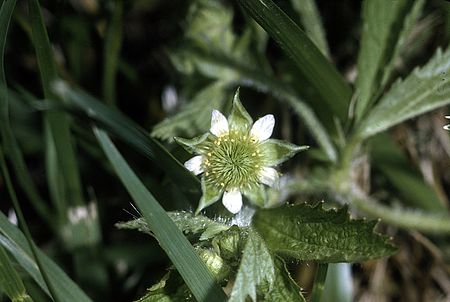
[252,204,396,262]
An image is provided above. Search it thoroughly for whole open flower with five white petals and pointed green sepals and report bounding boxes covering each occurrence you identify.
[175,90,308,214]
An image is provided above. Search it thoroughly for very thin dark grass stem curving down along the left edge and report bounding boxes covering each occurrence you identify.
[0,146,61,302]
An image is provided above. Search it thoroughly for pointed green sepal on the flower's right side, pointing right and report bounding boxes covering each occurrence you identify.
[261,139,309,166]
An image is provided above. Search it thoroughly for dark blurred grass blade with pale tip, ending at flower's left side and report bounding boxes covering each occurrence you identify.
[54,81,200,198]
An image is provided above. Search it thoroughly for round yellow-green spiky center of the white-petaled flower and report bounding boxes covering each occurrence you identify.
[203,131,263,190]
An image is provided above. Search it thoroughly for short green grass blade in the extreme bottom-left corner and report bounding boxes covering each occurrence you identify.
[0,246,33,302]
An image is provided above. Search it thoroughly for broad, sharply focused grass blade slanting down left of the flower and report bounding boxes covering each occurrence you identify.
[95,129,229,301]
